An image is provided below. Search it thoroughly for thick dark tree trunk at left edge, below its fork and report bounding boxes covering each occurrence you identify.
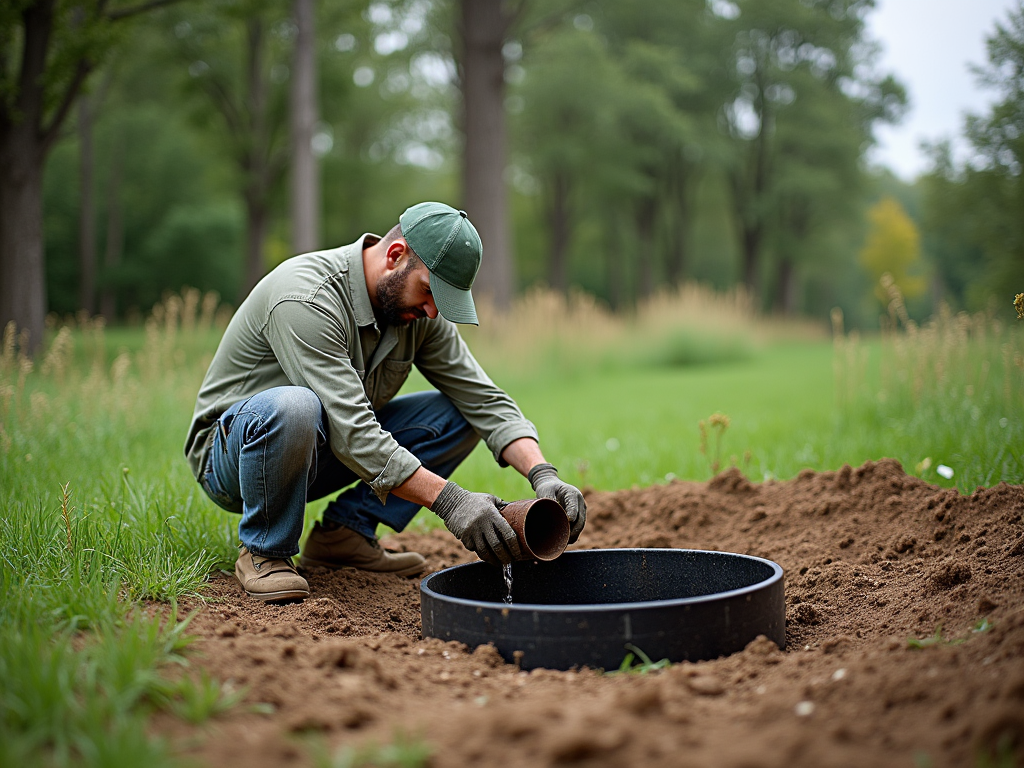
[0,130,46,353]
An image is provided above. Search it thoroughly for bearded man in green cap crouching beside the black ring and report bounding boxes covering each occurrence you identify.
[185,203,587,602]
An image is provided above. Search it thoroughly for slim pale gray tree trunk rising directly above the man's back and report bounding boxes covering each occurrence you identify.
[290,0,321,253]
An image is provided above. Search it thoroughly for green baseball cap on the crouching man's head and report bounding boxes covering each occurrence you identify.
[398,203,483,326]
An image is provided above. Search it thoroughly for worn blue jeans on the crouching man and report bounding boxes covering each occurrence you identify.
[200,387,479,557]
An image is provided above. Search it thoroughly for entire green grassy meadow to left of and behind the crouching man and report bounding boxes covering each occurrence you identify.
[0,294,1024,766]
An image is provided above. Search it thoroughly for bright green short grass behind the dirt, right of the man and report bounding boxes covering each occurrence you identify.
[407,333,1024,526]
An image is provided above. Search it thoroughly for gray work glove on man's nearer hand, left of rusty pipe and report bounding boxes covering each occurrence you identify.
[430,482,519,567]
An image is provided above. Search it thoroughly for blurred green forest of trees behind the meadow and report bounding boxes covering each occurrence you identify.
[0,0,1024,338]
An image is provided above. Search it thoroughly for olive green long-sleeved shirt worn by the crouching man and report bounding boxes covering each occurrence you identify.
[185,234,537,502]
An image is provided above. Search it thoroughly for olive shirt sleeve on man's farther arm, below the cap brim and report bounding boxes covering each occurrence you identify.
[416,317,539,467]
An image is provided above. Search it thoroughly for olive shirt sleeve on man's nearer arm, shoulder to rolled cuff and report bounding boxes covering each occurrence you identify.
[263,300,420,504]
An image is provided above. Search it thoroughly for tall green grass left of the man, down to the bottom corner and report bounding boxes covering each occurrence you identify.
[0,292,233,766]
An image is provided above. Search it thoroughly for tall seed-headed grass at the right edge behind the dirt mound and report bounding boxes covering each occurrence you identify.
[833,279,1024,493]
